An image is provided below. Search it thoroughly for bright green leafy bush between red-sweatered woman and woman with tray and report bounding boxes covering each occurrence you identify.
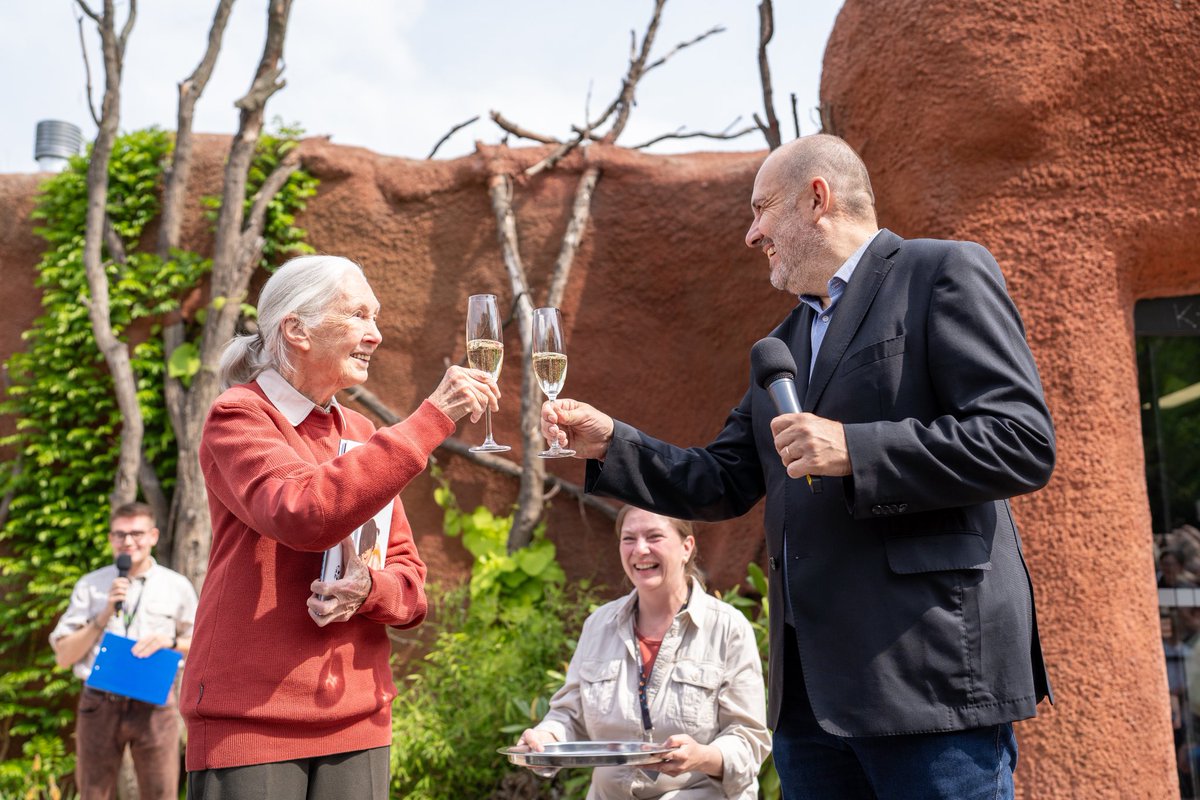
[391,470,595,800]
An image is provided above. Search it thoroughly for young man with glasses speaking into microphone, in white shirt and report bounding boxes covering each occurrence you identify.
[50,503,197,800]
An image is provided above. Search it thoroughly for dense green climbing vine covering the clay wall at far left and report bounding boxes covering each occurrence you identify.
[0,128,317,796]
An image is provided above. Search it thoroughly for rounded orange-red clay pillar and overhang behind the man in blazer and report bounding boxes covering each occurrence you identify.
[822,0,1200,800]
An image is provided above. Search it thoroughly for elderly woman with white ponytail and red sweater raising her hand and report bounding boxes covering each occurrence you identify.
[178,255,499,800]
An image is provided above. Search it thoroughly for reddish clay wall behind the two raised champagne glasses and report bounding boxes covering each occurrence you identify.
[0,137,791,599]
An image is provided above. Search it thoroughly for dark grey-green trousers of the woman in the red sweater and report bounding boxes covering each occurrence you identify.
[187,747,391,800]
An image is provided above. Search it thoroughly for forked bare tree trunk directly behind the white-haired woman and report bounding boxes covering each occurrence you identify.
[169,0,299,587]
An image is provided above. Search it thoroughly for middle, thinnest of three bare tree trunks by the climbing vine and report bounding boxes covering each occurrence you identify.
[157,0,233,566]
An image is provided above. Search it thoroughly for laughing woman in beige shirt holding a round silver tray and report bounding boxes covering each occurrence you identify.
[521,506,770,800]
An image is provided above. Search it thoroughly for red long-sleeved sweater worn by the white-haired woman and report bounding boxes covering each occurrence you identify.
[180,383,455,771]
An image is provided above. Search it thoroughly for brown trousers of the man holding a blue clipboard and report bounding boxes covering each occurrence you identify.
[76,686,179,800]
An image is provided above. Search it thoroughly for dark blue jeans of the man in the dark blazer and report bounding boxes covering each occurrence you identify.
[772,626,1016,800]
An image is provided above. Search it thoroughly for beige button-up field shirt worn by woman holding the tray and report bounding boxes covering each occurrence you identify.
[538,582,770,800]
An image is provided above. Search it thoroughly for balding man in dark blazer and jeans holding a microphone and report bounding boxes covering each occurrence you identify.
[542,136,1055,800]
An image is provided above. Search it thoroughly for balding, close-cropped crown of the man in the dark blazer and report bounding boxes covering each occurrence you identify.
[763,133,875,224]
